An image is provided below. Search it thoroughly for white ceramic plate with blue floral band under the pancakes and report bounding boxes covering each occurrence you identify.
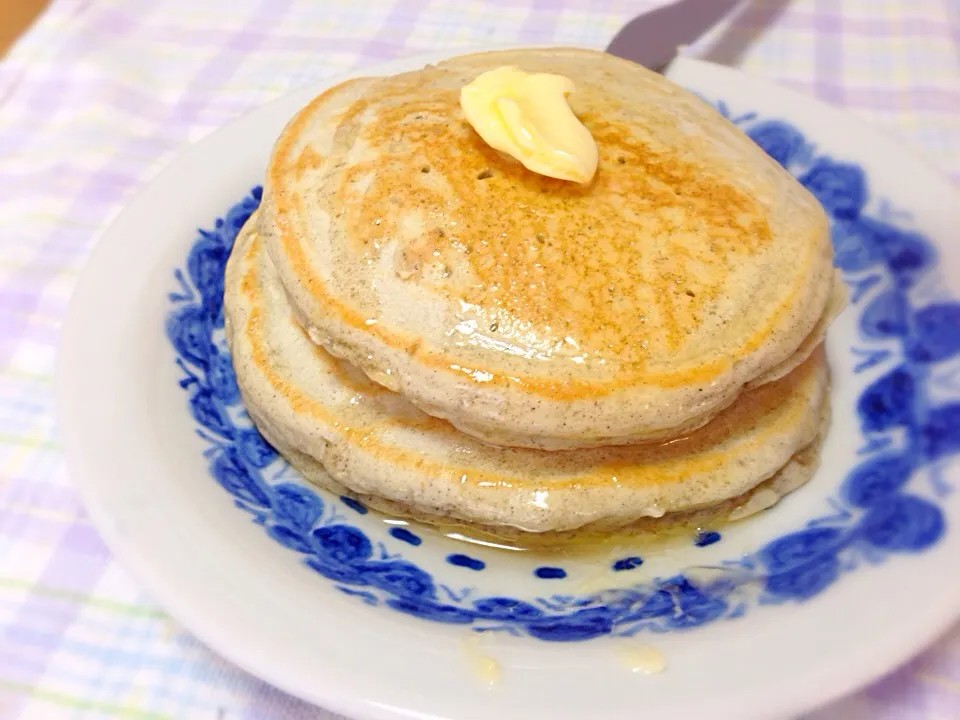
[59,56,960,720]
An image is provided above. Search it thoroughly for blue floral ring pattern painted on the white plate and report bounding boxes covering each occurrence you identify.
[166,107,960,641]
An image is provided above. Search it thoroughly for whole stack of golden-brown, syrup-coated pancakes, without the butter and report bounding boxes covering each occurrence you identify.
[225,49,843,532]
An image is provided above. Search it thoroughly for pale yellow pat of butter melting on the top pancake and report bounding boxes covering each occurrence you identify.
[460,67,598,183]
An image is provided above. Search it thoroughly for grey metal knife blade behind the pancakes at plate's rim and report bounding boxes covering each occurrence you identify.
[607,0,740,72]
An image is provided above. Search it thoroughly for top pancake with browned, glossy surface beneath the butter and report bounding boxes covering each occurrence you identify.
[259,49,842,450]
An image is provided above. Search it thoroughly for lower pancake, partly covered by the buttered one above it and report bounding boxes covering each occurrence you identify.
[224,218,828,532]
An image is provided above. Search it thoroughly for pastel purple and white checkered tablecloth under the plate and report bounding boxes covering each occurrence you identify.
[0,0,960,720]
